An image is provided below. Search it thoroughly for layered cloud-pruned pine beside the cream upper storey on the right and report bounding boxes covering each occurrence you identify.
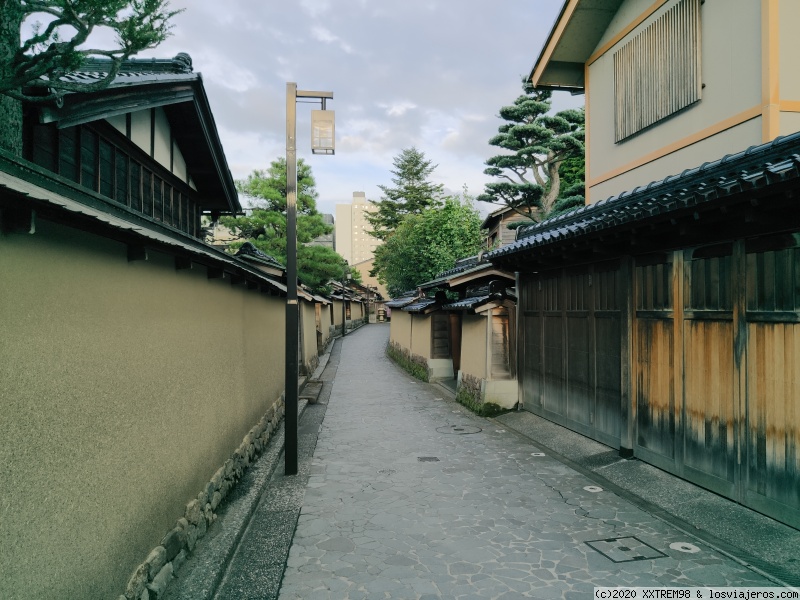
[478,81,585,221]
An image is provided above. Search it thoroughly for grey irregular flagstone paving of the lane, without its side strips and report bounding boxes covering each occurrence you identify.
[280,325,774,600]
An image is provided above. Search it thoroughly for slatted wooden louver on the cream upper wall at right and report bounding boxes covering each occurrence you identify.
[614,0,702,142]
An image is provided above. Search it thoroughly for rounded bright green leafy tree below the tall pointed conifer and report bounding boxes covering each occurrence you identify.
[372,192,483,296]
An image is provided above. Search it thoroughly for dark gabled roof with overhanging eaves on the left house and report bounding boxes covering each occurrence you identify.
[37,54,242,214]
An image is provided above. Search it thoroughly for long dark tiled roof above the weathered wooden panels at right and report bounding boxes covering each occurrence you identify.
[487,133,800,261]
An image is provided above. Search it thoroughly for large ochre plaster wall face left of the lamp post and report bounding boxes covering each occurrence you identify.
[0,219,284,600]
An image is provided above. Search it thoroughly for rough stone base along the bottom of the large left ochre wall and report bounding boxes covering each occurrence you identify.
[118,396,284,600]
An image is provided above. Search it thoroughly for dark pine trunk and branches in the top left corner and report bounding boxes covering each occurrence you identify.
[0,0,180,155]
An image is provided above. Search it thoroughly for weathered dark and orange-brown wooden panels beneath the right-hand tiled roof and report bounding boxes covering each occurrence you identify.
[519,235,800,526]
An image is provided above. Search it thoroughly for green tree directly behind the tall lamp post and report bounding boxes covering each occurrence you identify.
[220,158,344,292]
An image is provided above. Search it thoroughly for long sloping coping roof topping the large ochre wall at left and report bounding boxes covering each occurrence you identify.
[0,150,286,295]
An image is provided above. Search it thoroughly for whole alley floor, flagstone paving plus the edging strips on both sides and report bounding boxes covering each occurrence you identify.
[167,325,798,600]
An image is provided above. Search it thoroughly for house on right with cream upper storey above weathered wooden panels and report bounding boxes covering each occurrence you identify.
[496,0,800,526]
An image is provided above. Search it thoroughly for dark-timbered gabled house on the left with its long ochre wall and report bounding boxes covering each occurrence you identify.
[0,55,294,599]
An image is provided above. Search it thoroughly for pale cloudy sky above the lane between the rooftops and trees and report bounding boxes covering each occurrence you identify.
[140,0,583,213]
